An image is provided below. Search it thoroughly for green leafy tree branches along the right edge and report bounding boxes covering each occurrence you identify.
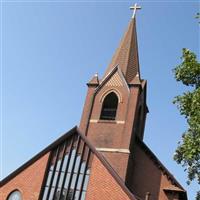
[174,49,200,200]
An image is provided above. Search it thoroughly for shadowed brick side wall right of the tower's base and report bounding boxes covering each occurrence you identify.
[129,143,181,200]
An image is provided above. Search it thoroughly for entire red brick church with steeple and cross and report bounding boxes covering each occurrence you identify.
[0,6,187,200]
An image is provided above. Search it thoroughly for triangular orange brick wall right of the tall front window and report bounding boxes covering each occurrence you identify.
[86,156,130,200]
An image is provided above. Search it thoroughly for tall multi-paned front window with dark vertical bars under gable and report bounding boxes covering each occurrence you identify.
[42,135,92,200]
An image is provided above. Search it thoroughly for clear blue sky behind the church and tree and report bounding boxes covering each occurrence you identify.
[1,0,199,200]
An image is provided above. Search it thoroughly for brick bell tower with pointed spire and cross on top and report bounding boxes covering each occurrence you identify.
[79,5,148,182]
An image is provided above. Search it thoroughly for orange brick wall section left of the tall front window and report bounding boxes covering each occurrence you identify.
[0,153,49,200]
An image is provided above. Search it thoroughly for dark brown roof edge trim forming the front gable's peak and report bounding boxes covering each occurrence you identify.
[0,126,138,200]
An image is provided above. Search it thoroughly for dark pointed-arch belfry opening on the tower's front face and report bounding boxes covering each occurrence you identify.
[100,92,118,120]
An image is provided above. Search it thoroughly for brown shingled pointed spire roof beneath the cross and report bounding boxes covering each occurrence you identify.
[105,16,140,83]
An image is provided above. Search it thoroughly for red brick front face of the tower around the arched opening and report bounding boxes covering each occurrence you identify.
[80,71,142,181]
